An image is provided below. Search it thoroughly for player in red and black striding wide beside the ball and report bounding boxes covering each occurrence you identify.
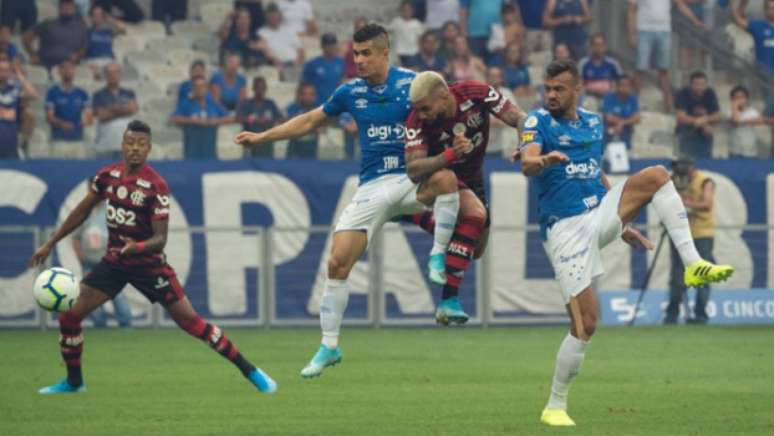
[30,120,277,394]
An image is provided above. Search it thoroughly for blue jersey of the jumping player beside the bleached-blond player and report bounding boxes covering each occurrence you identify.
[323,67,416,185]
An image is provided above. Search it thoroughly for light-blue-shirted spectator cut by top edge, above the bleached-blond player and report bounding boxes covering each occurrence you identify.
[460,0,503,60]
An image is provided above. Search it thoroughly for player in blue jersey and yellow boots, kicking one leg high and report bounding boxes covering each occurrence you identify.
[517,60,734,426]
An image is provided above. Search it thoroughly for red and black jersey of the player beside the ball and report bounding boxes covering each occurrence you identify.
[90,163,169,271]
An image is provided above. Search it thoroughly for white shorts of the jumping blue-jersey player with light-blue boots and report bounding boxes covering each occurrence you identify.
[336,174,425,244]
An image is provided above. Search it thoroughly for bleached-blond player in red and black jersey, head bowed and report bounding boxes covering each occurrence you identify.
[406,71,526,324]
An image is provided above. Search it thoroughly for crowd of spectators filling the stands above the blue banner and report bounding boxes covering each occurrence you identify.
[0,0,774,159]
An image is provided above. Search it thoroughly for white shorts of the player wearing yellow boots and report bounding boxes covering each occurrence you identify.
[543,181,626,303]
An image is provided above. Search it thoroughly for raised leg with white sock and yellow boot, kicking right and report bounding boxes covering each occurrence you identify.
[618,165,734,287]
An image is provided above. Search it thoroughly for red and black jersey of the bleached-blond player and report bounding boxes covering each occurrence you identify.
[406,80,511,183]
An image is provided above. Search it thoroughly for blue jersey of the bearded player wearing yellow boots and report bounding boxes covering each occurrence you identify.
[522,108,607,237]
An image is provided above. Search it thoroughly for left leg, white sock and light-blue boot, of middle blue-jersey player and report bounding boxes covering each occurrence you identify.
[301,230,368,378]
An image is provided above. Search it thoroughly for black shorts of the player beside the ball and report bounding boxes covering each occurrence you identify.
[82,259,185,306]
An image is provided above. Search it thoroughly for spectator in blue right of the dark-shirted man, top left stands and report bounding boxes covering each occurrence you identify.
[85,4,126,80]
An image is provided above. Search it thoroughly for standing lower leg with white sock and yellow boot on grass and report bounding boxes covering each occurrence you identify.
[540,287,597,427]
